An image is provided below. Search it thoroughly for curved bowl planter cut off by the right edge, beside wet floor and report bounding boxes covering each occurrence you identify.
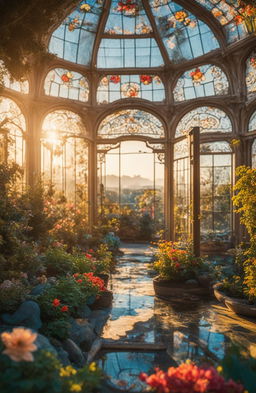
[213,283,256,318]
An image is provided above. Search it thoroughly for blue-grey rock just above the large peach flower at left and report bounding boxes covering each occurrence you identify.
[1,300,42,330]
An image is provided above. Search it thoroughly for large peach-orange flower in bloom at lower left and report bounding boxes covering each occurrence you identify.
[1,328,37,362]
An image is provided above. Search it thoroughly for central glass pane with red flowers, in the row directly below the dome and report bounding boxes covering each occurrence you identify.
[97,75,165,104]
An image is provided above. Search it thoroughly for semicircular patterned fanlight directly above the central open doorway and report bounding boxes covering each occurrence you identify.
[98,109,164,139]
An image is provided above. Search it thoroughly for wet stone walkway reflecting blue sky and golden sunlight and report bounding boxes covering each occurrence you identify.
[97,244,256,391]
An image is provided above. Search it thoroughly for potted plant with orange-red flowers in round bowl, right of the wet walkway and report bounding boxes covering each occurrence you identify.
[153,241,210,303]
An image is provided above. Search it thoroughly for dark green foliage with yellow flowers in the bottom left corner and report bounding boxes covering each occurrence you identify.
[0,348,102,393]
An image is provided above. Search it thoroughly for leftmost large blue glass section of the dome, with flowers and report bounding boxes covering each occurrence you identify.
[49,0,104,65]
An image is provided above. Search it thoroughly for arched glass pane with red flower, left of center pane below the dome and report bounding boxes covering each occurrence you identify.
[44,68,89,102]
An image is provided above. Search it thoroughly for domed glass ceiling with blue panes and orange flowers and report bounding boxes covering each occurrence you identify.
[49,0,252,69]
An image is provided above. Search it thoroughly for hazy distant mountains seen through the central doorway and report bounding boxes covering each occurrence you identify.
[103,175,164,189]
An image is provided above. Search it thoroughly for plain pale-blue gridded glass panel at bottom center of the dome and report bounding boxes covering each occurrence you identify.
[97,38,164,68]
